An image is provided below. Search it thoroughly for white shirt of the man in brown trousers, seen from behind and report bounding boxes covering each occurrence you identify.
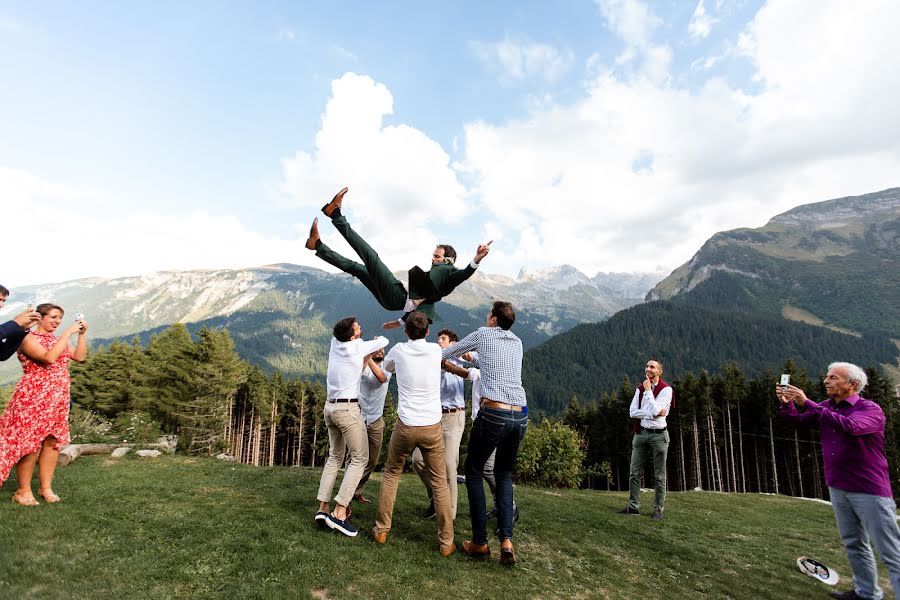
[383,339,441,427]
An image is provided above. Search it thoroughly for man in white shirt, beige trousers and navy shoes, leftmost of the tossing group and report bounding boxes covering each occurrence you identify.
[315,317,388,537]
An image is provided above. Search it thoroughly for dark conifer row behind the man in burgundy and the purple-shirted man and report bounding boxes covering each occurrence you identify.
[561,361,900,498]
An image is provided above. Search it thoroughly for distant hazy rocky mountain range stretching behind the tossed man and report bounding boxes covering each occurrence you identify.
[0,264,663,383]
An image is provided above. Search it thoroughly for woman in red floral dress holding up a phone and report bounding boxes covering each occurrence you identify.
[0,304,87,506]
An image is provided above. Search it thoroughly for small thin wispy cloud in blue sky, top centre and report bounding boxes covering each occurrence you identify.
[469,38,574,82]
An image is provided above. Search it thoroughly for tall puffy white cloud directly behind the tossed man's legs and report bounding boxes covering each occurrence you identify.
[279,73,468,270]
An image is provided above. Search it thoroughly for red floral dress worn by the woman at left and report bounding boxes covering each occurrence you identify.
[0,332,69,483]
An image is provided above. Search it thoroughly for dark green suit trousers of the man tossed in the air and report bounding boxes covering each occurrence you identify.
[316,215,407,310]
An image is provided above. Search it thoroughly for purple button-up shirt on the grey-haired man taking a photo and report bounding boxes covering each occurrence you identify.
[781,394,893,498]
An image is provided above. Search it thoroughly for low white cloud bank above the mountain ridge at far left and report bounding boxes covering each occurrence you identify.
[0,166,319,287]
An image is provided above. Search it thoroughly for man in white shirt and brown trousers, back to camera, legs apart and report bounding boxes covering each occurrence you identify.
[372,312,456,556]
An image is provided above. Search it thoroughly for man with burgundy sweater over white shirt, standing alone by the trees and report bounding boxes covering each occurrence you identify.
[619,360,672,521]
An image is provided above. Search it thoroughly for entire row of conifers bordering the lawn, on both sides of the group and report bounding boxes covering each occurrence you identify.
[65,324,900,497]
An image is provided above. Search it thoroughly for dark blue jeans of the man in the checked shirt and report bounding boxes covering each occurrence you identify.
[466,408,528,544]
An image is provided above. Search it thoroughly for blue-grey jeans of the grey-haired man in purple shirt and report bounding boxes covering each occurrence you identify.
[828,487,900,600]
